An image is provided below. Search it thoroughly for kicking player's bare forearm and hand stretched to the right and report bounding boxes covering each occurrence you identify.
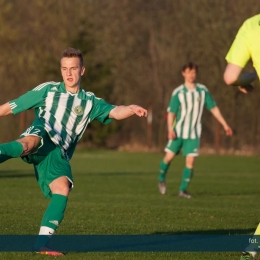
[109,105,147,120]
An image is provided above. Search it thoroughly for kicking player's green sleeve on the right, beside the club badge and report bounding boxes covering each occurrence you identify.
[90,96,115,124]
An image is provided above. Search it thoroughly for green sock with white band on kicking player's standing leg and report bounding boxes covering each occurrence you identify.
[34,194,68,250]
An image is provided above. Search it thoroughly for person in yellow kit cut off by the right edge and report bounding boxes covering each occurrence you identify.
[224,14,260,260]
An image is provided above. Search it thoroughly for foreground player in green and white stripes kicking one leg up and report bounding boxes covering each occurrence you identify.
[0,48,147,256]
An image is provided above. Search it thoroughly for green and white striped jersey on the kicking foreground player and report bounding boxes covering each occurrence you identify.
[9,82,115,158]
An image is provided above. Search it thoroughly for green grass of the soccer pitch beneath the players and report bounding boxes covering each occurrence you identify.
[0,151,260,260]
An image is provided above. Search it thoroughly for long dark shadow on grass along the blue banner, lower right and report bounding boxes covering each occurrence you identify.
[152,227,255,235]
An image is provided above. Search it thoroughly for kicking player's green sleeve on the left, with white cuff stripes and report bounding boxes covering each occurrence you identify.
[9,84,46,115]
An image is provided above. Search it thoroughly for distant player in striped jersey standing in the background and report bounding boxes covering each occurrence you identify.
[158,62,232,199]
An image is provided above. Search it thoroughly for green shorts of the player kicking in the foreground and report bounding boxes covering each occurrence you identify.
[20,119,73,198]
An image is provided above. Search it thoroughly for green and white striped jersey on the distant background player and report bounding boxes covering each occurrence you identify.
[167,83,216,139]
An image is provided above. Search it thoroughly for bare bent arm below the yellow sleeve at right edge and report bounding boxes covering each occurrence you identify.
[223,63,257,94]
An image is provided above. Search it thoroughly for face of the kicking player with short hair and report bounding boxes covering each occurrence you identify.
[60,57,85,92]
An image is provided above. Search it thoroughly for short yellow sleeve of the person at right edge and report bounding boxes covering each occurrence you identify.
[226,22,251,68]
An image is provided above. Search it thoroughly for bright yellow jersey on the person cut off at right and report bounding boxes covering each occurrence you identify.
[226,14,260,78]
